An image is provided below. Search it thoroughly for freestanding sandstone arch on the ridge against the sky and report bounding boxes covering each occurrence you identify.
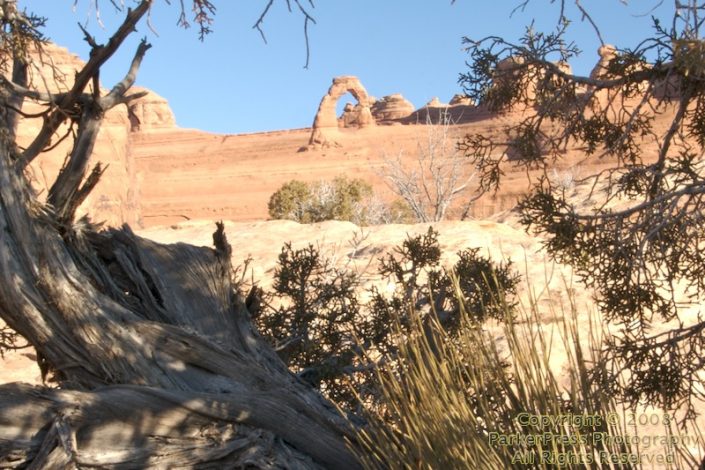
[309,75,375,146]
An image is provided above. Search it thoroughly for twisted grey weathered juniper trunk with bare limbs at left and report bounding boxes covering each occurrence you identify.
[0,0,359,468]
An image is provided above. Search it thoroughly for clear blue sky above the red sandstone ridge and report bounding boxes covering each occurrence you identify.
[19,0,673,133]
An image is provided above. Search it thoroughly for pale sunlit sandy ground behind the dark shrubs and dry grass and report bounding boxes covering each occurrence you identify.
[0,214,705,462]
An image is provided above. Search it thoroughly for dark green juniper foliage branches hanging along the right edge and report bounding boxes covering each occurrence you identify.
[461,0,705,414]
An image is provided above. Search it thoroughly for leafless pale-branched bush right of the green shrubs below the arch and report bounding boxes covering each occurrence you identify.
[381,109,474,222]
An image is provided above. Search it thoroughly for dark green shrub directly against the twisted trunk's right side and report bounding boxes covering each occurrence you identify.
[254,244,374,407]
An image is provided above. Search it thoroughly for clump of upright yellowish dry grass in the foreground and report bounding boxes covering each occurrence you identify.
[357,274,697,469]
